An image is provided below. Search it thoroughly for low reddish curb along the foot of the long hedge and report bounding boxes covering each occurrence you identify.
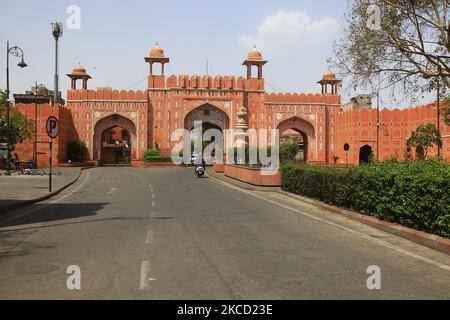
[208,168,450,255]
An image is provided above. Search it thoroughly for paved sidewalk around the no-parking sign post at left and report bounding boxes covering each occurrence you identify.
[0,167,81,214]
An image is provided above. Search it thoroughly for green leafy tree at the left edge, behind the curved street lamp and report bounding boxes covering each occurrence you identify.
[0,99,34,145]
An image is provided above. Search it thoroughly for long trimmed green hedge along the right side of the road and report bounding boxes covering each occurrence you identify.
[281,161,450,238]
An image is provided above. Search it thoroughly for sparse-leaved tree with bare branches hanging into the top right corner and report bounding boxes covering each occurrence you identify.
[330,0,450,98]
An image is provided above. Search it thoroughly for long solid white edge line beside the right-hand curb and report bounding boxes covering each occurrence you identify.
[210,178,450,271]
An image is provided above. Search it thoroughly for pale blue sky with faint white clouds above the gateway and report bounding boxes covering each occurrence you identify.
[0,0,436,107]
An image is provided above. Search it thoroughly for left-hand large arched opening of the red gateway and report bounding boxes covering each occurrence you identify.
[93,114,137,164]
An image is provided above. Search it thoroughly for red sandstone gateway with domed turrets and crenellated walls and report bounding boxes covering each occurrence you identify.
[7,45,450,169]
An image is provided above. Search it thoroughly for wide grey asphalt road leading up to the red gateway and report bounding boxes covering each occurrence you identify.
[0,167,450,299]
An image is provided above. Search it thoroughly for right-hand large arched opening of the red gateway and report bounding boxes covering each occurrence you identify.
[277,117,315,162]
